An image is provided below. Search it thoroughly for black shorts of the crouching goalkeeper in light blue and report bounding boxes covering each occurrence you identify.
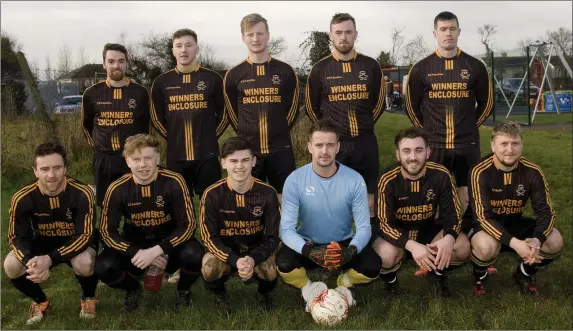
[276,239,382,278]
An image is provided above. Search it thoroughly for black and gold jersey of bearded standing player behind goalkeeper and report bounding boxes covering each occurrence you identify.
[306,52,386,140]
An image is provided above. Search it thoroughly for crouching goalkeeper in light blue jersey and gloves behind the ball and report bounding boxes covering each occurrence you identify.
[276,119,382,304]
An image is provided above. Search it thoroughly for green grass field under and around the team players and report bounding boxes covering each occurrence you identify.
[0,114,573,330]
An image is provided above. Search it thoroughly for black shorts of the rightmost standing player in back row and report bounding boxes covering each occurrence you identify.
[430,146,481,187]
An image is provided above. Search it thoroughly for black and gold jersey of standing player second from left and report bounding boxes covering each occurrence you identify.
[151,65,228,162]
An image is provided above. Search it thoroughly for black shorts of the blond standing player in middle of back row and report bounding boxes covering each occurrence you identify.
[252,147,296,193]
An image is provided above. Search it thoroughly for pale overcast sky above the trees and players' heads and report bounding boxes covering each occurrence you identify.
[1,1,572,78]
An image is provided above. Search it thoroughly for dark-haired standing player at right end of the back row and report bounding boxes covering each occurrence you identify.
[406,12,493,233]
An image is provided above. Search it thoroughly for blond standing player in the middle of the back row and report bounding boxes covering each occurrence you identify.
[225,14,299,201]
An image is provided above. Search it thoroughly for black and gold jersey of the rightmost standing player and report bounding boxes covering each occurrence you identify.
[405,49,493,149]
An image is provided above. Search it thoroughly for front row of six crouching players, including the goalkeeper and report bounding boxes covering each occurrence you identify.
[4,120,563,324]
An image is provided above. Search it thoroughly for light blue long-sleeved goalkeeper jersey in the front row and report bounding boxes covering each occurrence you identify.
[280,162,372,254]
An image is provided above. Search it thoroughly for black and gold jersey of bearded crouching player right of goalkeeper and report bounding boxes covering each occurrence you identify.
[376,161,462,248]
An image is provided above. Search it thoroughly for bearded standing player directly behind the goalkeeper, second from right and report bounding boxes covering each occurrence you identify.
[306,13,386,228]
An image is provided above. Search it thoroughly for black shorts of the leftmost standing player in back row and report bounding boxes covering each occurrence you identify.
[93,151,130,207]
